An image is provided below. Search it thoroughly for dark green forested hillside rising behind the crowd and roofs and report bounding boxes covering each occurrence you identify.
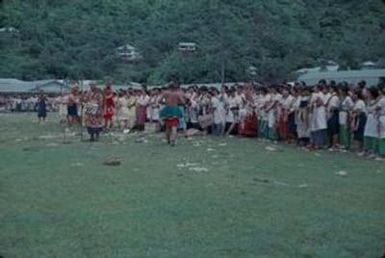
[0,0,385,84]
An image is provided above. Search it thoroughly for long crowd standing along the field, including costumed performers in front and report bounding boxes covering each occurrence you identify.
[3,80,385,159]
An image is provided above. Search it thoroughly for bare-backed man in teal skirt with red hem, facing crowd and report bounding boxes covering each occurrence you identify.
[160,85,184,146]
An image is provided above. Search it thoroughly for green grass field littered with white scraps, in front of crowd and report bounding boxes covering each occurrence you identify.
[0,114,385,258]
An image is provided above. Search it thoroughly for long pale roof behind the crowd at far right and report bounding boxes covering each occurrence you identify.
[298,69,385,86]
